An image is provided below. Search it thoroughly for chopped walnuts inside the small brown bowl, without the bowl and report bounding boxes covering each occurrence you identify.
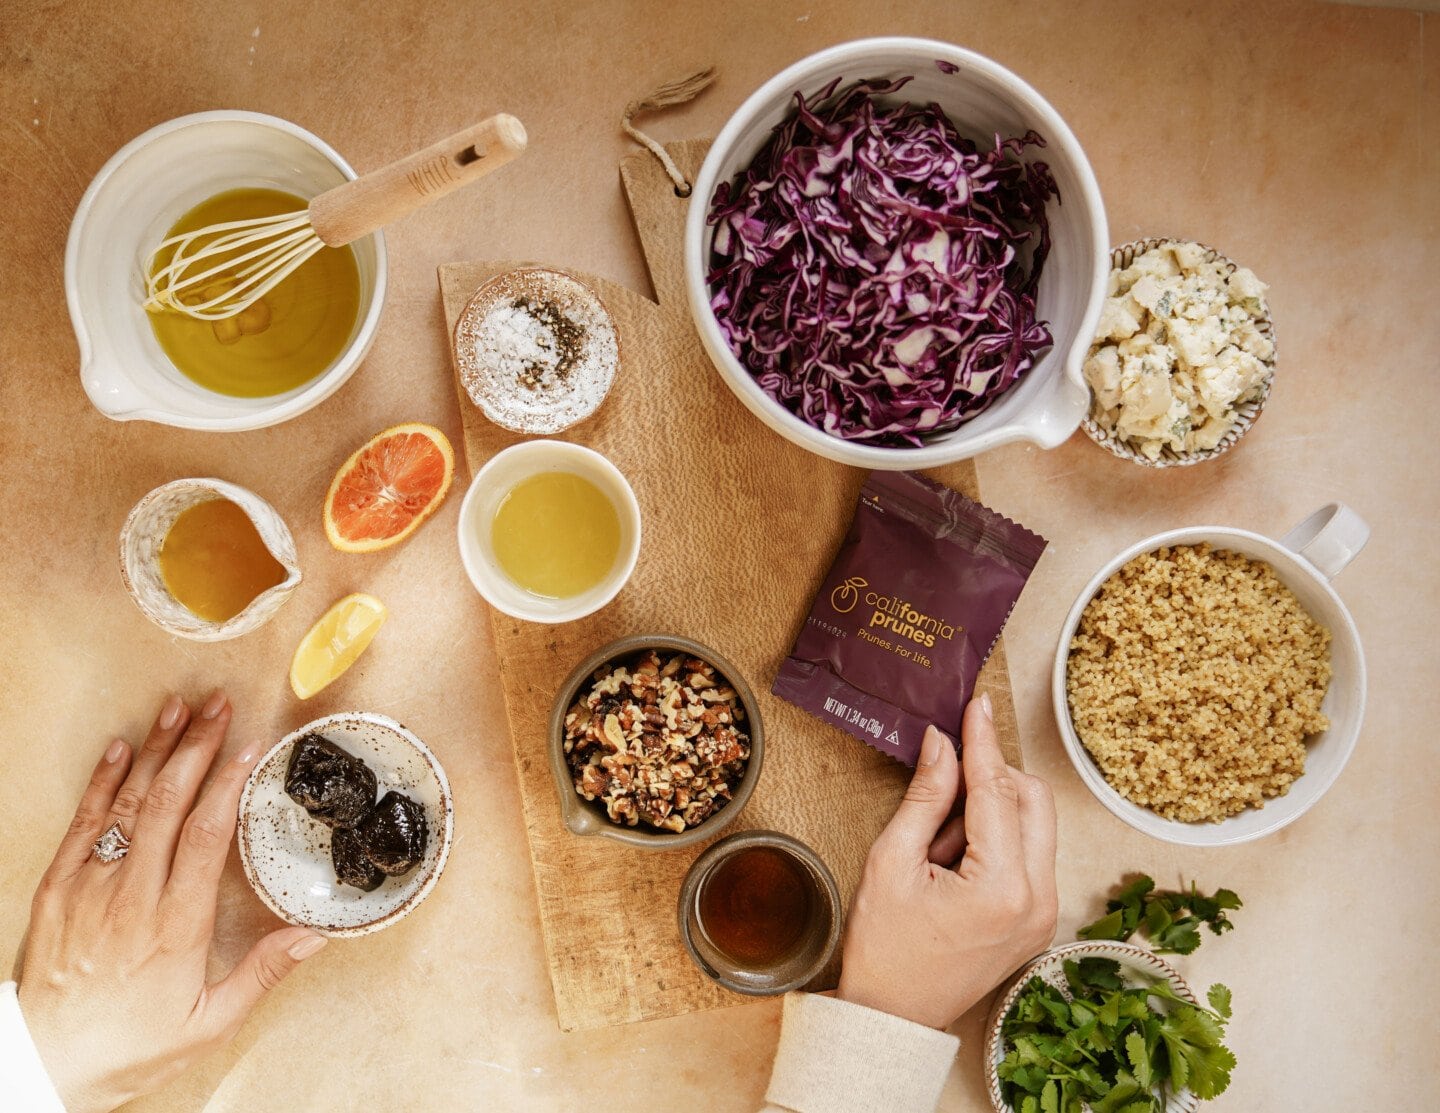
[564,649,750,832]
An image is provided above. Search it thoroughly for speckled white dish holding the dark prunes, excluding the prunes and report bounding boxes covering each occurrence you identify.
[239,711,455,936]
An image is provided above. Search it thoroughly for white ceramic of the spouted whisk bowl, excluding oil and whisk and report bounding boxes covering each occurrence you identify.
[65,111,387,432]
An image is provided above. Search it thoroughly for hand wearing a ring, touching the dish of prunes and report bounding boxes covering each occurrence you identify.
[19,691,325,1113]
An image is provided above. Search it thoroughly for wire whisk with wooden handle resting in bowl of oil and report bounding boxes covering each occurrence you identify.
[145,114,526,321]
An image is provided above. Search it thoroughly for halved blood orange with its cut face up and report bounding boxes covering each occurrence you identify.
[325,422,455,553]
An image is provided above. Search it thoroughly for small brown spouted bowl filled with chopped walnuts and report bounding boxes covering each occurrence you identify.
[549,635,765,850]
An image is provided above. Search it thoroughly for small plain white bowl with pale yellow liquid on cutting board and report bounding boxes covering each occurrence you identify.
[459,441,641,622]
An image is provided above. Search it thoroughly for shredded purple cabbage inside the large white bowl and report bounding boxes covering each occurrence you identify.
[708,78,1058,446]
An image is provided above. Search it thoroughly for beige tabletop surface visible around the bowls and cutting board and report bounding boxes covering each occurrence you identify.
[0,0,1440,1113]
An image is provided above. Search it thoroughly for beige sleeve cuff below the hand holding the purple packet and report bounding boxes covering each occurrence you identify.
[765,993,960,1113]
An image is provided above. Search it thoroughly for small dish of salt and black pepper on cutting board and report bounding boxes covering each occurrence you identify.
[455,268,621,435]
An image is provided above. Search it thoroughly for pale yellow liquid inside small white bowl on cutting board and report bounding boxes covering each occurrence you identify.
[491,471,621,599]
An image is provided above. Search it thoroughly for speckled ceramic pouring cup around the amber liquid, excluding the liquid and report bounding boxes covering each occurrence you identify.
[120,479,301,642]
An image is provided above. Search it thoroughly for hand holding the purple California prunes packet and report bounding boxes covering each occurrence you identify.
[838,694,1057,1028]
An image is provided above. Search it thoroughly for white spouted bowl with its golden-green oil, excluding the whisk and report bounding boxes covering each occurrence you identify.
[65,111,386,431]
